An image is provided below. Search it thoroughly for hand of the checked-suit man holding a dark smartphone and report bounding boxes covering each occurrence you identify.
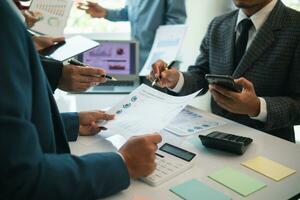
[209,78,260,117]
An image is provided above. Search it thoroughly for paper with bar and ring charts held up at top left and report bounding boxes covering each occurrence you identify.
[29,0,73,36]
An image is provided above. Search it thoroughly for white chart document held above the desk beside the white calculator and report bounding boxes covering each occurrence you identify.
[101,84,200,146]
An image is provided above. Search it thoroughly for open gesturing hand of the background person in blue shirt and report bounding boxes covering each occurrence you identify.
[77,1,107,18]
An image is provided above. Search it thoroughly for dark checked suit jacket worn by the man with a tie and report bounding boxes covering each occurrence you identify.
[176,1,300,141]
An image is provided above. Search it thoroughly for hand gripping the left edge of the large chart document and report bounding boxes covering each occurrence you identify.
[78,111,115,136]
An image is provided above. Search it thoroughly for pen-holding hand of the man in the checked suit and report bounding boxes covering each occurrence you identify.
[147,60,180,89]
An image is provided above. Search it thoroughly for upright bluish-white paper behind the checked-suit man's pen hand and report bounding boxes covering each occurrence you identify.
[140,25,187,76]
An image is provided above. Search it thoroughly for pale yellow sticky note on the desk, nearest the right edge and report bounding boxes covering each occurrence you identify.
[241,156,296,181]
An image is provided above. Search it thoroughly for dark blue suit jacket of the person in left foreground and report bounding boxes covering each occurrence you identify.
[0,1,129,200]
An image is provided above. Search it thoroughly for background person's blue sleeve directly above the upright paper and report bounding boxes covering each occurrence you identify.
[165,0,186,24]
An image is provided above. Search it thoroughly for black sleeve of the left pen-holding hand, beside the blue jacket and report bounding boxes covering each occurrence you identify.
[41,58,63,93]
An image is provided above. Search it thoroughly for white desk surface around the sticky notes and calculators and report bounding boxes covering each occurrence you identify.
[56,92,300,200]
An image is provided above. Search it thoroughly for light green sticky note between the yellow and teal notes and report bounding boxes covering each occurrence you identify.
[208,167,266,197]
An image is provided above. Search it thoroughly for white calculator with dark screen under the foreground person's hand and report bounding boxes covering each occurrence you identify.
[141,143,196,186]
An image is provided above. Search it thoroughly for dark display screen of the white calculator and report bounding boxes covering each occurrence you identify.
[159,143,196,162]
